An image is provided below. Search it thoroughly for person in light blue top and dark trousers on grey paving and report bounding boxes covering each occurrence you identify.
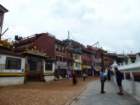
[100,69,107,94]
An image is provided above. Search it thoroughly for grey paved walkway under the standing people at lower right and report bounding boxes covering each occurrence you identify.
[71,81,140,105]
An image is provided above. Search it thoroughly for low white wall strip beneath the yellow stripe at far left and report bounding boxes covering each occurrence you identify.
[0,77,24,86]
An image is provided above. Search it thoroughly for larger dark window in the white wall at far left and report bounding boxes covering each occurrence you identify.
[5,57,21,70]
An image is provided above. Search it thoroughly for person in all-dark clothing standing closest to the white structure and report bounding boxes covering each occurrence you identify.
[115,67,124,95]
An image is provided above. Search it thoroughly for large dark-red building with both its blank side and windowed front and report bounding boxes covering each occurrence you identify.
[14,33,73,77]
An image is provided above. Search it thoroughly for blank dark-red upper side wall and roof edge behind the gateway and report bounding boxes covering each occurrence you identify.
[14,33,55,58]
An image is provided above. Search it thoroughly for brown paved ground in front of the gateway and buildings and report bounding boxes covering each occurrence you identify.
[0,77,97,105]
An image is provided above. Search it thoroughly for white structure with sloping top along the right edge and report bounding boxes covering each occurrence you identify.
[112,55,140,99]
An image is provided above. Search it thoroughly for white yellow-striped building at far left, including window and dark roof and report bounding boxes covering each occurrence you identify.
[0,46,25,85]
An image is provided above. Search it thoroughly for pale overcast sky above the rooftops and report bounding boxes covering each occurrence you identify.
[1,0,140,53]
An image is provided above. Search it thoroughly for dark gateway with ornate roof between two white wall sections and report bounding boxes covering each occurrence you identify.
[23,51,47,82]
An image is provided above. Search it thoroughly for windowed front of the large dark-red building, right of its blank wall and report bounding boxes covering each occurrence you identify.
[55,39,73,77]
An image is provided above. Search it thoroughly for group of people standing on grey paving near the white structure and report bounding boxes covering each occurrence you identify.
[100,67,123,95]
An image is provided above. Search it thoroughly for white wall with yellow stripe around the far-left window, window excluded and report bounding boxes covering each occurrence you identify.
[0,54,25,86]
